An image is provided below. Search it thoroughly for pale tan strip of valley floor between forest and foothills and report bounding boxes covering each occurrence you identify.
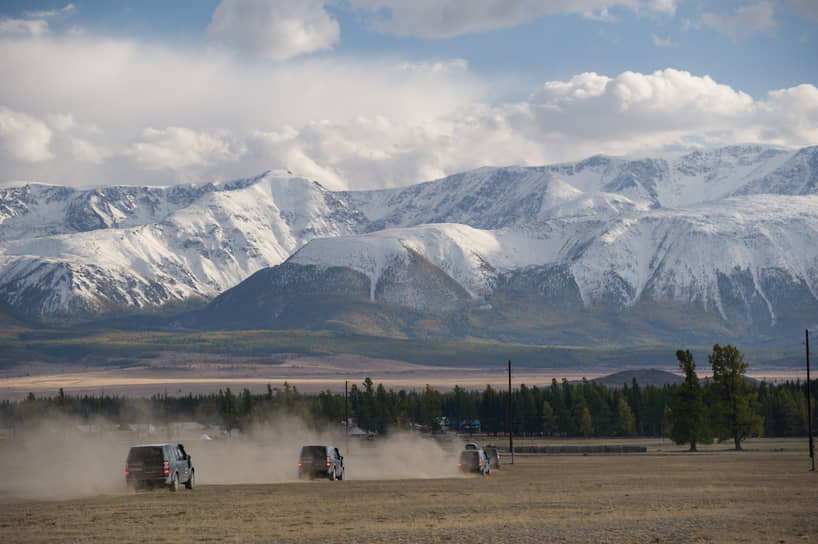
[0,352,805,400]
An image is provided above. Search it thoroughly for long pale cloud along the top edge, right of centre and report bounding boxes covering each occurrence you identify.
[349,0,676,39]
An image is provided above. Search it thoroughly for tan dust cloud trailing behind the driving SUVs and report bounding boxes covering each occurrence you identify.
[0,418,463,500]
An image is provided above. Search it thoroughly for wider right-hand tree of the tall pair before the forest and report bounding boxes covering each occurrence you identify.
[708,344,764,450]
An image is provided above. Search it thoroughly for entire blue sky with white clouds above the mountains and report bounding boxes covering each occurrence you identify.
[0,0,818,188]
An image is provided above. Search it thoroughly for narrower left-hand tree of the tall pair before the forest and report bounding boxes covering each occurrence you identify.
[670,350,709,451]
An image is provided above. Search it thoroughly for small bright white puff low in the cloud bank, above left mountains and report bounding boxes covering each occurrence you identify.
[126,127,245,170]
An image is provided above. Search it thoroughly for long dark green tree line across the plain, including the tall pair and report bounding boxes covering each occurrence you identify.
[0,345,818,450]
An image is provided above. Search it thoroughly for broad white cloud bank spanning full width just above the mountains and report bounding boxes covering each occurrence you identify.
[0,31,818,189]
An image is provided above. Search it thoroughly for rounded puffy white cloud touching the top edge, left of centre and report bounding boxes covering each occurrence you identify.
[207,0,340,61]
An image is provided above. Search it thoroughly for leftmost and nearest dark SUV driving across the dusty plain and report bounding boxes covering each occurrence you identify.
[125,444,196,491]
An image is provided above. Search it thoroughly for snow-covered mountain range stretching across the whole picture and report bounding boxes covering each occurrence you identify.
[0,146,818,342]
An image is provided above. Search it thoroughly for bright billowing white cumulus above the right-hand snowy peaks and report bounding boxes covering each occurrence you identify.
[510,69,818,158]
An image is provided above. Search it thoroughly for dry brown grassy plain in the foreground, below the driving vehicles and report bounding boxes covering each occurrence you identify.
[0,452,818,543]
